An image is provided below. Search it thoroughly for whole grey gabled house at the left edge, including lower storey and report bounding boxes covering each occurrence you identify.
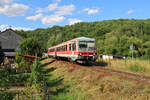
[0,29,23,58]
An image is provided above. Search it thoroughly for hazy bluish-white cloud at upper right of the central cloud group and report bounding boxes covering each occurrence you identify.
[55,4,75,15]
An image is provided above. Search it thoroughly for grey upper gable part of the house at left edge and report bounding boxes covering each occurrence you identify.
[0,29,23,49]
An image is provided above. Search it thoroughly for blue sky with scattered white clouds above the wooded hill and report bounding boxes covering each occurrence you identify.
[0,0,150,31]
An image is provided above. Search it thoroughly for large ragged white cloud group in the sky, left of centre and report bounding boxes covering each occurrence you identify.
[30,3,75,25]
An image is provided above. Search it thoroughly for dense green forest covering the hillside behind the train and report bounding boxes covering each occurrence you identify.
[16,19,150,59]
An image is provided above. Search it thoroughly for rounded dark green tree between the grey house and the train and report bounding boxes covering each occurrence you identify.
[19,37,44,57]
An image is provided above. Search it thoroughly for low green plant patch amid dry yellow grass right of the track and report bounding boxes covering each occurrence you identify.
[129,64,146,72]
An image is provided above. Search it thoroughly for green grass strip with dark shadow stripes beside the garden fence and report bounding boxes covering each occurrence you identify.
[41,60,67,96]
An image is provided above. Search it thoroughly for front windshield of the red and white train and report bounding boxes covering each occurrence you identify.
[79,41,96,52]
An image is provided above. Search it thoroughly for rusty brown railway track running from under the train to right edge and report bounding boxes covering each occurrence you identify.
[57,60,150,86]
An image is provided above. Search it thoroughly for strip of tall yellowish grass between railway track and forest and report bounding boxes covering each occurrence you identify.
[102,59,150,74]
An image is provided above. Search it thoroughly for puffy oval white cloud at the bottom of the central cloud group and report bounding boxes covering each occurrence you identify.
[41,15,65,25]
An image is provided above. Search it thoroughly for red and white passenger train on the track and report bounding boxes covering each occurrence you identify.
[48,37,97,62]
